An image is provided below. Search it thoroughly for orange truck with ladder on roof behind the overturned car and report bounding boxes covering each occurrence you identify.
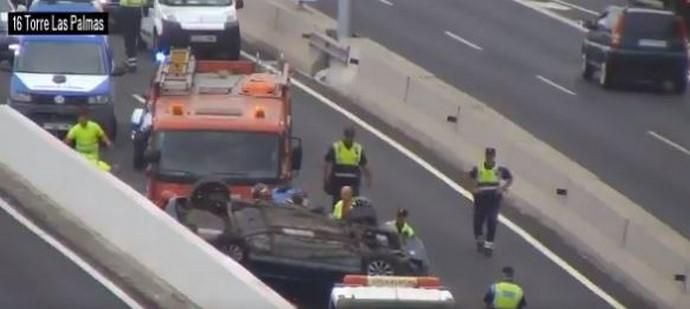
[131,49,302,208]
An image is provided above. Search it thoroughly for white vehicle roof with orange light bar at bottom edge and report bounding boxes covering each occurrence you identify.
[328,275,456,309]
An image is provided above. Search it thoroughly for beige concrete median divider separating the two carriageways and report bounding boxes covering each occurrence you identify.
[240,0,690,308]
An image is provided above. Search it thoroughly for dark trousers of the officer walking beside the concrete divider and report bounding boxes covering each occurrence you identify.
[473,191,501,242]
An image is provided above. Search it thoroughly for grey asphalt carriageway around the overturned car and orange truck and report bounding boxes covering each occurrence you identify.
[39,34,647,308]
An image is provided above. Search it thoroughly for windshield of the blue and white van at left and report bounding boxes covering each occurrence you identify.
[14,41,108,75]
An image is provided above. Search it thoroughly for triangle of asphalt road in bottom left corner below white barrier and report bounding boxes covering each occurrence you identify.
[0,197,128,309]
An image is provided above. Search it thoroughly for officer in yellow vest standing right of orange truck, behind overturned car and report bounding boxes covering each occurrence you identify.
[323,127,371,207]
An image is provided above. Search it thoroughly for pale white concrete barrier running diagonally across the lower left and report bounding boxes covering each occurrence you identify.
[0,105,292,309]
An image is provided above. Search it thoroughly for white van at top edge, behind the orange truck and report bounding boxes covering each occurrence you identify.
[141,0,244,60]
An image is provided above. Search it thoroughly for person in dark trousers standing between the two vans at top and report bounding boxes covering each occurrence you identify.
[116,0,149,73]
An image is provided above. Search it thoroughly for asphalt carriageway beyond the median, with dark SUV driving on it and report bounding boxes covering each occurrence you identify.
[310,0,690,237]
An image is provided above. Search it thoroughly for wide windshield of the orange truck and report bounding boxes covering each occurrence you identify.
[157,131,280,179]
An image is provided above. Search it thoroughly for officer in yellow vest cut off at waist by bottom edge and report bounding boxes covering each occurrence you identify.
[484,266,527,309]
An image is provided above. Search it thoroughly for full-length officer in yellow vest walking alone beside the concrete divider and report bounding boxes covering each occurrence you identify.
[470,148,513,256]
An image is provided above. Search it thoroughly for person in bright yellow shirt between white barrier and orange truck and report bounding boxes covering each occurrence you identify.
[64,109,112,161]
